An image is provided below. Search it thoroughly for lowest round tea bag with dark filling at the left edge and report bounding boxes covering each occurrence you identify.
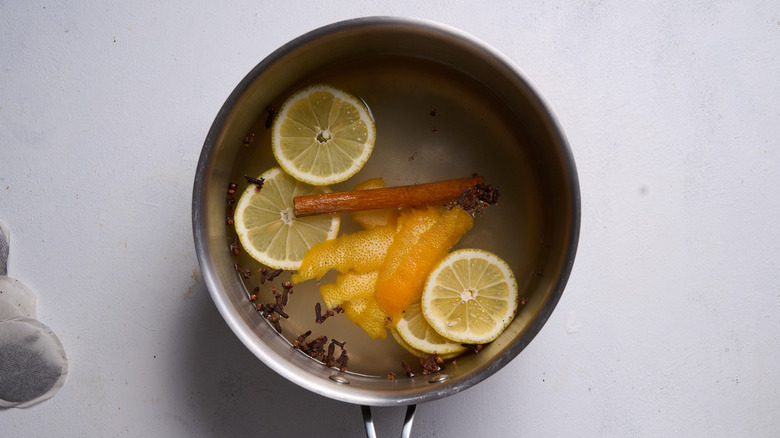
[0,318,68,408]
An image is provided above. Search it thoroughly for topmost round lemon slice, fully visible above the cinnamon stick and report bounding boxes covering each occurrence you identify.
[271,85,376,186]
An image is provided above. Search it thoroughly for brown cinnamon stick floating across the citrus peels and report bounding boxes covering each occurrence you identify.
[293,176,485,217]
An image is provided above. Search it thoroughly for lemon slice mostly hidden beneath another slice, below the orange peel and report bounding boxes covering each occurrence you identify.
[393,303,466,359]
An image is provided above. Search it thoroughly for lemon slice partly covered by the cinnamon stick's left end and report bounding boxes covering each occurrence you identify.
[234,167,340,269]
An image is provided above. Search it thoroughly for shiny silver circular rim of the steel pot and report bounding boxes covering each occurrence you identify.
[192,16,581,406]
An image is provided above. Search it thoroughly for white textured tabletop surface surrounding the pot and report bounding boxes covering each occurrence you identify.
[0,0,780,437]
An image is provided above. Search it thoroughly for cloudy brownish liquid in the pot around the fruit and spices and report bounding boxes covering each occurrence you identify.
[227,56,542,377]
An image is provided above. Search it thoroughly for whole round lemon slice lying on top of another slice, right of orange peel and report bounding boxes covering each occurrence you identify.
[421,249,517,344]
